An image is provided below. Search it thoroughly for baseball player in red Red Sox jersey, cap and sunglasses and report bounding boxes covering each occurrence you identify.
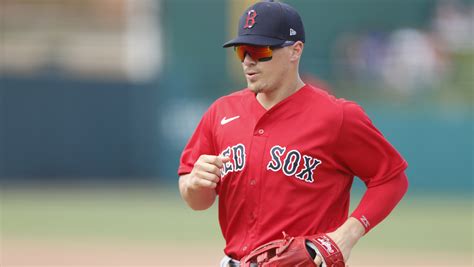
[178,2,408,266]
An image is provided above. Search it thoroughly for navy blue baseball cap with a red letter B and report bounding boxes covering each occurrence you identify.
[223,1,305,47]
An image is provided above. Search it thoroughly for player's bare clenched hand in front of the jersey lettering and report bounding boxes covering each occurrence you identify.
[188,155,230,189]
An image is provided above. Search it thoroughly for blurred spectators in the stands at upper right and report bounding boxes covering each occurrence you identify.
[335,0,474,96]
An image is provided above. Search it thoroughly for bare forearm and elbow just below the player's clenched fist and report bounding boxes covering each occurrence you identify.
[179,174,216,210]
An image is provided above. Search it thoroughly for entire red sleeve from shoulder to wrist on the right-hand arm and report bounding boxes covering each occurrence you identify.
[335,102,408,233]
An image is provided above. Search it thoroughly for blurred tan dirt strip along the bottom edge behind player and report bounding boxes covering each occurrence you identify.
[0,240,473,267]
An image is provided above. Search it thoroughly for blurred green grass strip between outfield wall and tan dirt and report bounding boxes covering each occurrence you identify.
[0,188,473,266]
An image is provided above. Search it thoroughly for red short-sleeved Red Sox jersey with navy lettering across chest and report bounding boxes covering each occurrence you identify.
[178,85,407,259]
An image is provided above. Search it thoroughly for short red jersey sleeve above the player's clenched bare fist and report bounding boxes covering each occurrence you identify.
[178,106,217,176]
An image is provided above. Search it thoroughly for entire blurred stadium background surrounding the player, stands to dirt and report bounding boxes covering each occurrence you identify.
[0,0,474,266]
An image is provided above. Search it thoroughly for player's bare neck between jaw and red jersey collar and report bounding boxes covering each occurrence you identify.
[256,76,305,110]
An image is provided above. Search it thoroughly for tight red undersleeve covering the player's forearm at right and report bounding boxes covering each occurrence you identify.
[351,172,408,232]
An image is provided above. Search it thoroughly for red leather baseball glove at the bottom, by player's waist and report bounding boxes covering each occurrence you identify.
[240,232,345,267]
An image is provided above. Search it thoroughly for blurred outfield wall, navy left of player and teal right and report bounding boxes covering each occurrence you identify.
[0,76,474,190]
